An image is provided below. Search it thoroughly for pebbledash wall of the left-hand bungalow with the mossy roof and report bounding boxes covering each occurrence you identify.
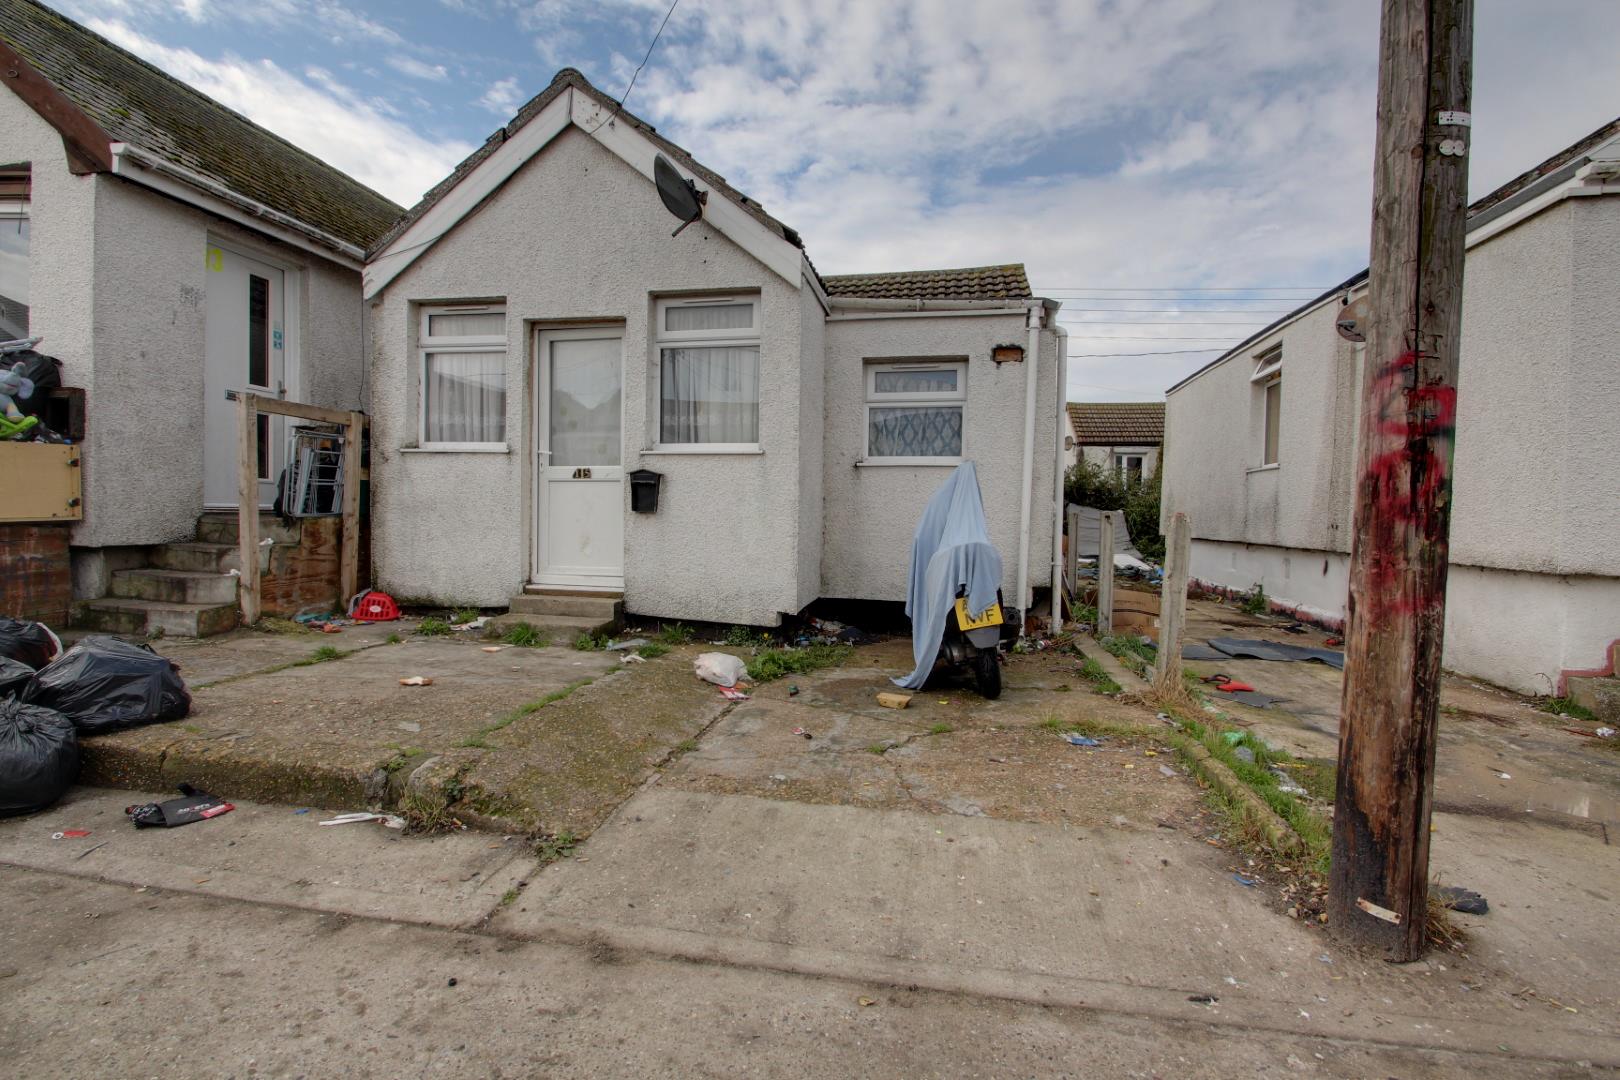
[0,94,365,599]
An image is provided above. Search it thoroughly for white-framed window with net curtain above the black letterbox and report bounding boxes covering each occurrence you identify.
[654,296,760,452]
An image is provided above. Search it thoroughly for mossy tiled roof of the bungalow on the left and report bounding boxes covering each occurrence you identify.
[0,0,400,249]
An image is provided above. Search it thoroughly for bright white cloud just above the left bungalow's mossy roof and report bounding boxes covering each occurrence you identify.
[89,19,473,206]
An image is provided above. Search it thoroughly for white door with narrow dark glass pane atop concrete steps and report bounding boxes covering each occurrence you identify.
[203,243,287,507]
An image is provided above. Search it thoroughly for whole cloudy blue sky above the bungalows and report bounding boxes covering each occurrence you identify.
[53,0,1620,400]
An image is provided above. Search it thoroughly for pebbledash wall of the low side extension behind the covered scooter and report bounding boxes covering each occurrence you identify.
[821,301,1058,606]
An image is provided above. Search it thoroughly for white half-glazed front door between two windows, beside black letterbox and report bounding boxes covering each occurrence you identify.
[535,327,624,589]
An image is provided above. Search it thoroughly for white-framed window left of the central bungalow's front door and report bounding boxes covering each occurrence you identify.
[418,304,507,450]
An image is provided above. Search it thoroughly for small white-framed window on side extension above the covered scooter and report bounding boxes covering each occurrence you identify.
[865,359,967,465]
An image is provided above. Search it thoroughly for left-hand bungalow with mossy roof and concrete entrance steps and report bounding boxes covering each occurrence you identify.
[0,0,403,635]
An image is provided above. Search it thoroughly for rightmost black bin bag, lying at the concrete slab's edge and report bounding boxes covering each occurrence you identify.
[23,636,191,735]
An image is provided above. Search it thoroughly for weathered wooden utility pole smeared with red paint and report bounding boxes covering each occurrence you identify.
[1328,0,1474,960]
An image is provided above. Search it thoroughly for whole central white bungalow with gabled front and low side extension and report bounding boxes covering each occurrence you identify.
[365,70,1066,627]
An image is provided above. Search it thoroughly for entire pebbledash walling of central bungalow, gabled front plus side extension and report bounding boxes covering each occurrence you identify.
[369,128,1056,625]
